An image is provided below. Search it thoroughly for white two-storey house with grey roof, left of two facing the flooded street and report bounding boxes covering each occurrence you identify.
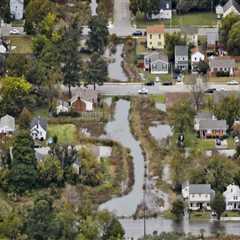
[182,184,215,211]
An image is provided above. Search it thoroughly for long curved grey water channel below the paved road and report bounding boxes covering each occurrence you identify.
[100,100,144,217]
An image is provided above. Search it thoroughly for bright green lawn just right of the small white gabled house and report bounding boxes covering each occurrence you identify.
[48,124,77,144]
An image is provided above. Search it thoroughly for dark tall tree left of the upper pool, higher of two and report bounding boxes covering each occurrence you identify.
[87,16,109,54]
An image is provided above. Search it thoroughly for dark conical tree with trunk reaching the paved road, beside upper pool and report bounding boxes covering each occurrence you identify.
[85,53,108,90]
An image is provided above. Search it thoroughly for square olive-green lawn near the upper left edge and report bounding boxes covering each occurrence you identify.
[8,36,32,54]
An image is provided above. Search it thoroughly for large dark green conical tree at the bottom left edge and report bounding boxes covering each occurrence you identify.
[24,194,62,240]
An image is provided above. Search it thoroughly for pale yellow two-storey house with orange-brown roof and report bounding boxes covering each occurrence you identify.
[146,25,165,49]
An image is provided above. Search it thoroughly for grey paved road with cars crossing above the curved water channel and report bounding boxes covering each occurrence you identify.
[73,83,240,96]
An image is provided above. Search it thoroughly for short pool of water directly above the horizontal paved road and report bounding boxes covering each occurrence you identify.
[105,44,128,81]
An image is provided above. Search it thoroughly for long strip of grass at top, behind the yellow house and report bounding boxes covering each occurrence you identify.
[136,12,217,28]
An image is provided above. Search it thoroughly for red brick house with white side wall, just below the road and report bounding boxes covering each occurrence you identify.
[70,88,98,112]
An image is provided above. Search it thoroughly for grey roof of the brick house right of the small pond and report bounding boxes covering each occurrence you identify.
[199,119,228,131]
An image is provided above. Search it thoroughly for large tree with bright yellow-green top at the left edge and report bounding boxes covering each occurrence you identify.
[0,77,32,115]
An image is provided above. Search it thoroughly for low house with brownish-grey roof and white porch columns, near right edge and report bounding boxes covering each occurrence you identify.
[209,57,236,76]
